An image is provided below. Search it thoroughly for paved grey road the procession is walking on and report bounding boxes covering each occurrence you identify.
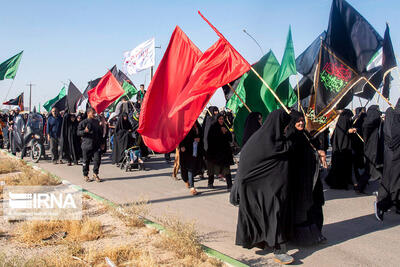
[31,155,400,267]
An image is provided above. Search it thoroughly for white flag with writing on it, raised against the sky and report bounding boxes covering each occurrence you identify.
[122,37,155,75]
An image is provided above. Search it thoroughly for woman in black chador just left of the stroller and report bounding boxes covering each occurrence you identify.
[112,113,135,164]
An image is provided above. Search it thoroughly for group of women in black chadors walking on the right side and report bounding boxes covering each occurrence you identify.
[230,100,400,264]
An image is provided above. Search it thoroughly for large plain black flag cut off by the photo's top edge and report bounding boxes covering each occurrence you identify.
[326,0,383,73]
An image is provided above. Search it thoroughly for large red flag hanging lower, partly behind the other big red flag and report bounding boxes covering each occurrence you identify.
[138,26,202,153]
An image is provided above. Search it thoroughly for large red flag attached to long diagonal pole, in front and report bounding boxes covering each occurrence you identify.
[169,38,250,118]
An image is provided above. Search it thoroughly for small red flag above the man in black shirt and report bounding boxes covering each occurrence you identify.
[87,71,125,113]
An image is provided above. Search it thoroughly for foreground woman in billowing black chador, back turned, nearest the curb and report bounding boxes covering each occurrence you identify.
[230,110,293,264]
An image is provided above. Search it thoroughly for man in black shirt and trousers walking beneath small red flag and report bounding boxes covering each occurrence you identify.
[78,108,105,182]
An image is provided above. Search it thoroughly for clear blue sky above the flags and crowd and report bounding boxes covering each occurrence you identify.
[0,0,400,111]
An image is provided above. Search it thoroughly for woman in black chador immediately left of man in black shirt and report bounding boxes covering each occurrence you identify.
[60,113,82,166]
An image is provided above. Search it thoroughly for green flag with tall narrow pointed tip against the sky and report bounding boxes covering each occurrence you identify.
[261,27,297,112]
